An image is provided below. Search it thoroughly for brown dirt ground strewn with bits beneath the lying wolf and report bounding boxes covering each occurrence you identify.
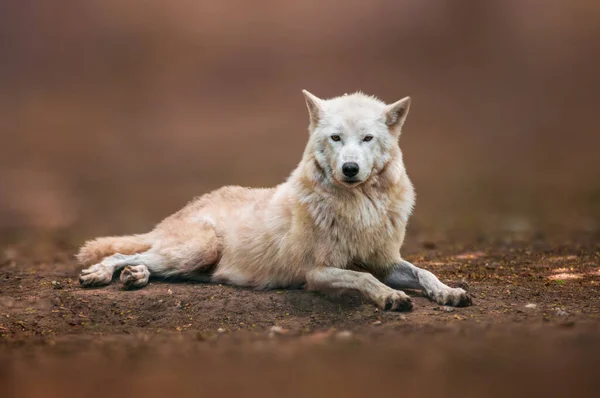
[0,235,600,397]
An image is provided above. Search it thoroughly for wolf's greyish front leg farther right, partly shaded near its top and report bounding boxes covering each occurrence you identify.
[385,260,472,307]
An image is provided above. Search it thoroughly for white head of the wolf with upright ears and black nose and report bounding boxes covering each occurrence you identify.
[302,90,410,187]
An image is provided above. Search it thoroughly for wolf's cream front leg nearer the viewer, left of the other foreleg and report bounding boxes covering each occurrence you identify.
[306,267,412,311]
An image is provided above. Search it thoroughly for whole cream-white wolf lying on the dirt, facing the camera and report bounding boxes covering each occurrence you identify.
[77,91,471,310]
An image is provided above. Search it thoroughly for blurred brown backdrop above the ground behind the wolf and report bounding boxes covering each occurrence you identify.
[0,0,600,239]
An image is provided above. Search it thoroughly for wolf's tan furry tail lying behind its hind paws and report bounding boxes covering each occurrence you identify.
[76,235,152,265]
